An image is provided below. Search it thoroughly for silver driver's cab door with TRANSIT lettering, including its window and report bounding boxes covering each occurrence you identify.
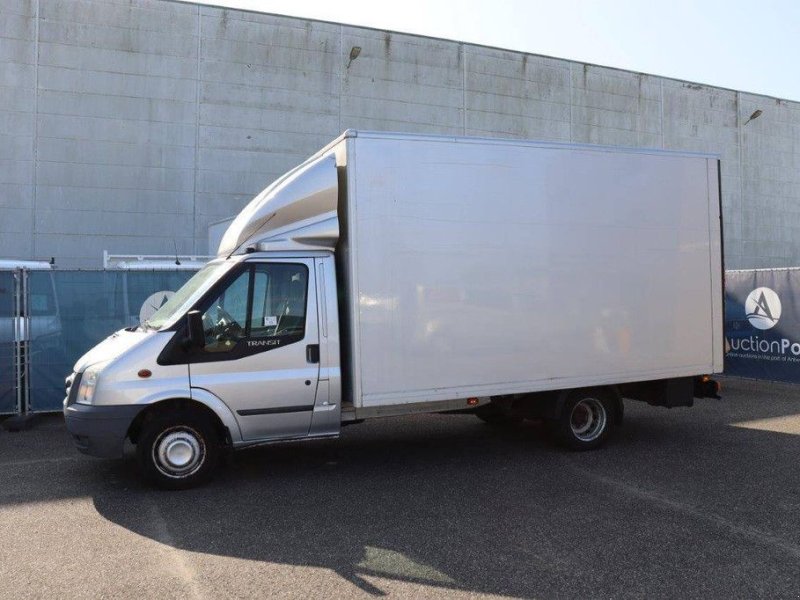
[189,259,319,441]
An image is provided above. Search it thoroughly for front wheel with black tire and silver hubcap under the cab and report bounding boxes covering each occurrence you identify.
[136,409,221,490]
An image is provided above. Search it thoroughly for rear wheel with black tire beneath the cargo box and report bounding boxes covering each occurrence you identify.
[548,389,615,450]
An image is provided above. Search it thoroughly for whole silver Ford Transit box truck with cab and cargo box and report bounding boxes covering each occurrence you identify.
[64,131,723,488]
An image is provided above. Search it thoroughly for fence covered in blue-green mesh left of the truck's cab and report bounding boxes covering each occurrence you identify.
[0,269,194,414]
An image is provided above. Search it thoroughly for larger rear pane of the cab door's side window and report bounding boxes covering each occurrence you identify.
[248,263,308,344]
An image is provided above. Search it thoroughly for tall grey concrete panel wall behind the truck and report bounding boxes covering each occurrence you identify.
[0,0,800,268]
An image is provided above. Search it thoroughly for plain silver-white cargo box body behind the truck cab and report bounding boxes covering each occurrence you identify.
[325,132,723,409]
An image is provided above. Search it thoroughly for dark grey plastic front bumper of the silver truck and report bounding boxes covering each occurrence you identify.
[64,403,145,458]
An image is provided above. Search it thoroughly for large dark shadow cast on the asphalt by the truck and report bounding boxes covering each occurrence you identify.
[94,400,800,597]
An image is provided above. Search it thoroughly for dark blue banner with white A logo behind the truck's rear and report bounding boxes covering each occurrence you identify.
[725,269,800,383]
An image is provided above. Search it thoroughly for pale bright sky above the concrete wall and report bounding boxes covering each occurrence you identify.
[192,0,800,100]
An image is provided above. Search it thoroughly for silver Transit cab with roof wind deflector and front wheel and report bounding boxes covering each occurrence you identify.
[64,156,341,488]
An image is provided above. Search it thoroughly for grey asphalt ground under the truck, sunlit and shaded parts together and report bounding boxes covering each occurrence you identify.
[0,380,800,598]
